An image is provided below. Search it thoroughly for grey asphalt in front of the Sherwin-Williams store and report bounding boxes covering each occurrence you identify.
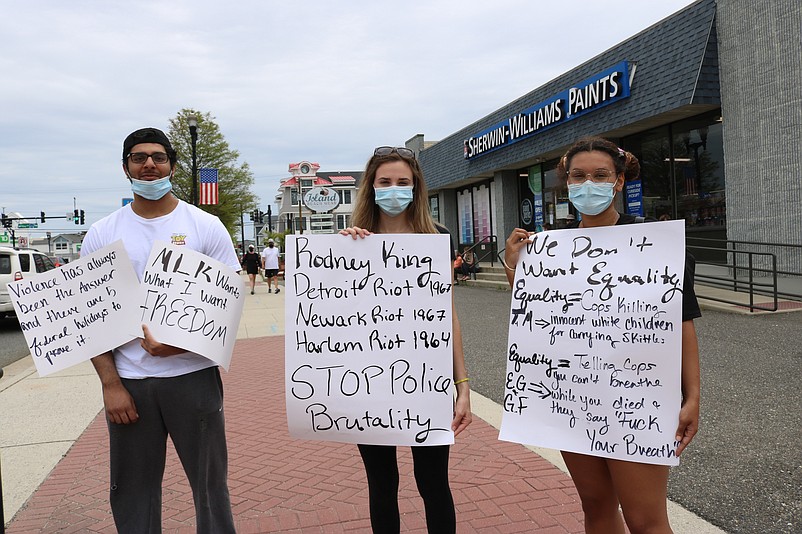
[455,286,802,534]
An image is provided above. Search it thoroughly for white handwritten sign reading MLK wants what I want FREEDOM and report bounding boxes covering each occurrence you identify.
[134,241,245,370]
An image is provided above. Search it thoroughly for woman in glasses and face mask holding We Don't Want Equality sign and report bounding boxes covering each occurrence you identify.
[504,137,701,534]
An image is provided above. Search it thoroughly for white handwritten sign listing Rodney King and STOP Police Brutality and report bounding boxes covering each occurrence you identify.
[285,234,454,445]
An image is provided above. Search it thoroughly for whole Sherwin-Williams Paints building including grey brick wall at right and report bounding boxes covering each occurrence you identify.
[407,0,802,272]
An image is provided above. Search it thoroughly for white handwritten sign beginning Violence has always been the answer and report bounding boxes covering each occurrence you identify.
[8,241,138,376]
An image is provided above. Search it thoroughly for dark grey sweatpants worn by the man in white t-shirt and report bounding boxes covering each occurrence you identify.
[108,367,234,534]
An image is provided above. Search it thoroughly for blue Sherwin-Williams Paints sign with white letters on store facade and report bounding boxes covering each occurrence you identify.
[464,61,629,159]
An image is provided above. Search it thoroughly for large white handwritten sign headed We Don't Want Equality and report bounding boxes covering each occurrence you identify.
[499,221,685,465]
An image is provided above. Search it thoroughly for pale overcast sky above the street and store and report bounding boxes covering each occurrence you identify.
[0,0,692,237]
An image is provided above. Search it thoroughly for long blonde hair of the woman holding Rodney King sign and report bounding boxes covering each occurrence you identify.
[351,152,438,234]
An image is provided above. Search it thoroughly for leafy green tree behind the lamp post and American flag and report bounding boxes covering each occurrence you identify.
[167,108,258,236]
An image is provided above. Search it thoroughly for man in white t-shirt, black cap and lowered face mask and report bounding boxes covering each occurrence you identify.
[81,128,240,533]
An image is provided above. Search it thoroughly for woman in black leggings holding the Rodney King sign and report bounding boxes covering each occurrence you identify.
[340,147,472,534]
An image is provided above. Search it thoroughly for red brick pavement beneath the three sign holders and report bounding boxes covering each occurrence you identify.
[6,336,583,534]
